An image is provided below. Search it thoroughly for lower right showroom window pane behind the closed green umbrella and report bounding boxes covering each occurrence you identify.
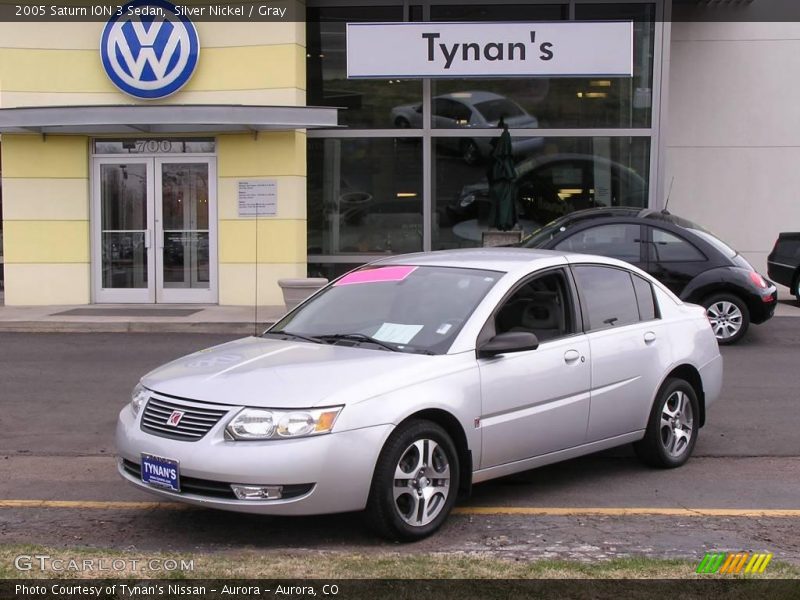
[433,137,650,250]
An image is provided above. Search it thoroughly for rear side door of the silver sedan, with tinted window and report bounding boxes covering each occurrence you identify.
[572,264,670,442]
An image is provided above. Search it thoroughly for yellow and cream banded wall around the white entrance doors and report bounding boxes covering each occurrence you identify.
[0,10,306,305]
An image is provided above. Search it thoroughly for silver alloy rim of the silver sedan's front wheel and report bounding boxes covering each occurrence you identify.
[392,439,450,527]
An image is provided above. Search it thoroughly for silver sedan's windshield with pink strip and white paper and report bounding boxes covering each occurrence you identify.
[265,265,503,354]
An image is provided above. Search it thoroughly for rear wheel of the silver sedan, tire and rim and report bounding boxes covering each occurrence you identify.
[633,377,700,469]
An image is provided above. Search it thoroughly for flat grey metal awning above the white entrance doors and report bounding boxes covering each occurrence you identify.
[0,104,338,135]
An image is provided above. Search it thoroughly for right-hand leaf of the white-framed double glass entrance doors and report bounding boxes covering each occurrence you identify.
[155,157,217,303]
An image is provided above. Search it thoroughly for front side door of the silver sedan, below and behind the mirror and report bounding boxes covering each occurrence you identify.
[478,269,590,469]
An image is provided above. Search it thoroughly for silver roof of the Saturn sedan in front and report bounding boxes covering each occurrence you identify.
[371,247,566,273]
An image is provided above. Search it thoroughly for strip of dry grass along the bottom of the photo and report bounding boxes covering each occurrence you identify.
[0,545,800,579]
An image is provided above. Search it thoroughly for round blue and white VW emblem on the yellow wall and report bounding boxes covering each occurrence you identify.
[100,0,200,100]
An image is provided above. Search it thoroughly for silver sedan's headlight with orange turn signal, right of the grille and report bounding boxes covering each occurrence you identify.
[225,406,342,440]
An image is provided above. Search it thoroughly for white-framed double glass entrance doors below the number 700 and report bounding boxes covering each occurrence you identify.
[92,156,217,303]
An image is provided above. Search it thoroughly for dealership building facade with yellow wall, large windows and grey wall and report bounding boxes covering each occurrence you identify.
[0,0,800,305]
